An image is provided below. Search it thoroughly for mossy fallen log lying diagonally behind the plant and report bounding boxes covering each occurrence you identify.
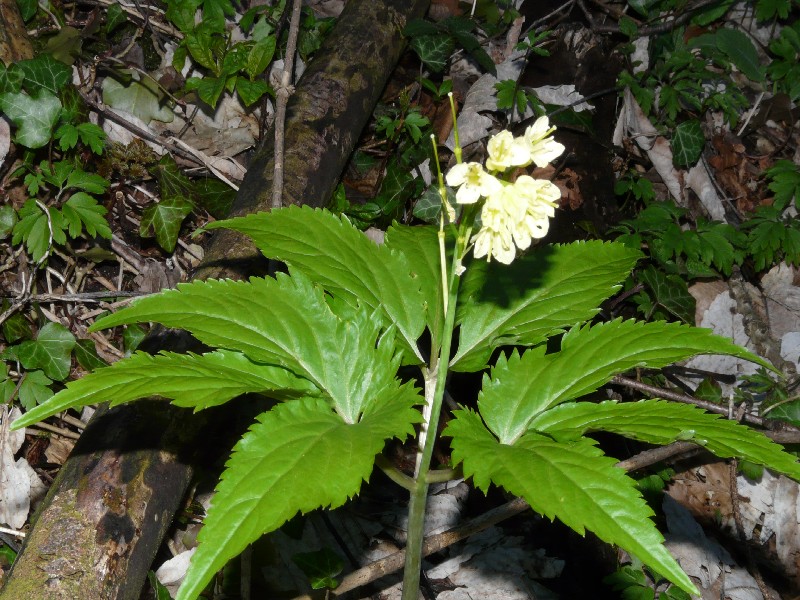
[0,0,429,600]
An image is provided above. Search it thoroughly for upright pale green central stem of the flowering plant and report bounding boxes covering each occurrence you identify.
[402,222,470,600]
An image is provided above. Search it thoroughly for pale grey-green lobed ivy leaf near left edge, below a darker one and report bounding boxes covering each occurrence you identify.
[0,88,61,149]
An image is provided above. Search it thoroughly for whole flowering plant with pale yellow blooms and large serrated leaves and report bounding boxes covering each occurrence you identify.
[13,98,800,600]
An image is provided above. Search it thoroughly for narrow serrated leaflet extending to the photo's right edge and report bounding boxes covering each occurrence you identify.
[530,400,800,479]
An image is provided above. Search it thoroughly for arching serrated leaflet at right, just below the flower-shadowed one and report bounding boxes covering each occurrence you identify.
[478,319,774,443]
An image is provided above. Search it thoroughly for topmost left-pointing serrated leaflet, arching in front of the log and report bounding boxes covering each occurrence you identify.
[207,206,432,361]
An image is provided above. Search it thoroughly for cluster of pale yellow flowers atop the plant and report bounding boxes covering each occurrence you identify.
[446,117,564,264]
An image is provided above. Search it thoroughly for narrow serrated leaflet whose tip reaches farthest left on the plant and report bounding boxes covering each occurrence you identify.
[11,350,319,427]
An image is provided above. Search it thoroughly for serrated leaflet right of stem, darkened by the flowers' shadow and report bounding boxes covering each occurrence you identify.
[451,241,641,371]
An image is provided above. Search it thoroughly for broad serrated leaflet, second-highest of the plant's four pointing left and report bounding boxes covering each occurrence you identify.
[92,273,422,422]
